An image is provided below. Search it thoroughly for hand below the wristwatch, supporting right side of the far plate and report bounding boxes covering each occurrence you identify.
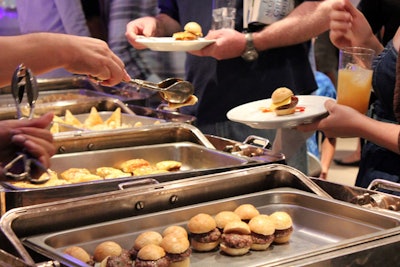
[189,29,246,60]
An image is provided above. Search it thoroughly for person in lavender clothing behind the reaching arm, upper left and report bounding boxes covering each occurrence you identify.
[15,0,91,78]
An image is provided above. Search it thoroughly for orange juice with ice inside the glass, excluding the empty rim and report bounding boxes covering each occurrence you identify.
[337,68,372,114]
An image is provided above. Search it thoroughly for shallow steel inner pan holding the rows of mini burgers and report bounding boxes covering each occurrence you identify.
[19,189,400,266]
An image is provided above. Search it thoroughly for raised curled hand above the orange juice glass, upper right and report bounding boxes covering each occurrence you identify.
[329,0,374,48]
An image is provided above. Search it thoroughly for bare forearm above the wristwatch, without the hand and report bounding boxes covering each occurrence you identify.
[253,1,330,51]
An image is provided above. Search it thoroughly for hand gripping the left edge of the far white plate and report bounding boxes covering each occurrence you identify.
[125,17,157,49]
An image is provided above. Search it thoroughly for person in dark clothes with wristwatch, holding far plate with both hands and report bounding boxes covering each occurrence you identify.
[126,0,331,173]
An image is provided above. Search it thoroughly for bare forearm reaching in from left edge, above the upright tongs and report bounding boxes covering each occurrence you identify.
[0,33,68,86]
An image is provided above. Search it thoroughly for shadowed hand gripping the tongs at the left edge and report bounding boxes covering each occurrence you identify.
[0,113,56,171]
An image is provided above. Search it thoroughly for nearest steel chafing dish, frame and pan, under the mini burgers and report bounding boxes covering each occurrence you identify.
[0,164,400,266]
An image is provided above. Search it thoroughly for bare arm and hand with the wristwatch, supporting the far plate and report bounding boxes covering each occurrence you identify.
[190,0,336,59]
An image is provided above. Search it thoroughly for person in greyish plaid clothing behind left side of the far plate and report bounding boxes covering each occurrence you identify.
[101,0,186,82]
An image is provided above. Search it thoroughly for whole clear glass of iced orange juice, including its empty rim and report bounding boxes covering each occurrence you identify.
[337,47,375,113]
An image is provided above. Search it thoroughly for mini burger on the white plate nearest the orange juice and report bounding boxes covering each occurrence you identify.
[270,87,299,116]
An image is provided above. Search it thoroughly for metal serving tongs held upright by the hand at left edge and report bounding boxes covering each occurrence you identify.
[3,64,50,184]
